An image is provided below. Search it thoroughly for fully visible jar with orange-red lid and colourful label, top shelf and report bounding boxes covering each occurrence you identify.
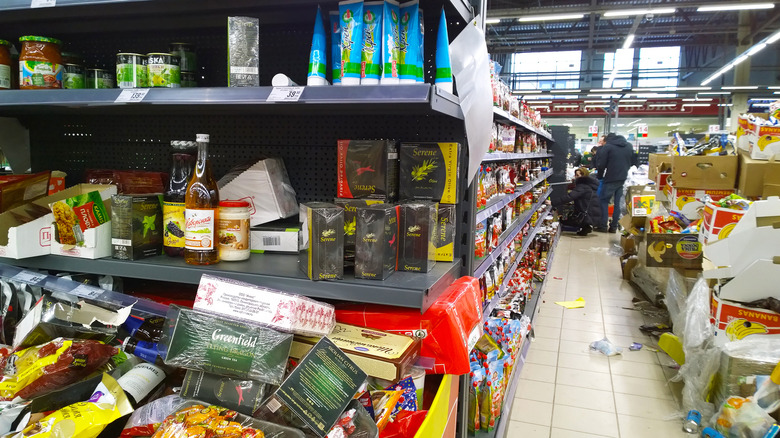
[19,35,63,90]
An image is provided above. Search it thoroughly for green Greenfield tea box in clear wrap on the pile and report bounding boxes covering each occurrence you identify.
[158,305,293,385]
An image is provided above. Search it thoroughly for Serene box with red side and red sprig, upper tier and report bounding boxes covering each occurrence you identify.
[336,140,398,201]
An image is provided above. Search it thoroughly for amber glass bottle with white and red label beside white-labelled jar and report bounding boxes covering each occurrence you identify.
[184,134,219,265]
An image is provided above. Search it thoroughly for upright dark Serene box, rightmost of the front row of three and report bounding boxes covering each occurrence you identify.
[398,201,438,272]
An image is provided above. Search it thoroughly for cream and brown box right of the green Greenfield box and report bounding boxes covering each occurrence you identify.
[290,323,420,381]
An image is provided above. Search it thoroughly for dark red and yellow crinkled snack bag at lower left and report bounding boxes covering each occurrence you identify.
[0,338,118,400]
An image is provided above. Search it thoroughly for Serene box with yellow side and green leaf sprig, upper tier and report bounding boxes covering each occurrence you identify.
[399,143,460,204]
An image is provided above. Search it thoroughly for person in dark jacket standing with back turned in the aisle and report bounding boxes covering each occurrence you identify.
[596,133,638,233]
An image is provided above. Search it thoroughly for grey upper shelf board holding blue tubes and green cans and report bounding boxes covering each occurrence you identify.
[0,84,463,119]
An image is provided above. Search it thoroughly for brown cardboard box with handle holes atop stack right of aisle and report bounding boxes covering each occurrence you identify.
[672,155,738,190]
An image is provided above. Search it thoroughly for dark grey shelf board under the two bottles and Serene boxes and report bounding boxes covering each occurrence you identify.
[0,254,461,311]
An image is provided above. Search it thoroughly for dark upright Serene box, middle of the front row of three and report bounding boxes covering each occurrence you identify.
[355,204,400,280]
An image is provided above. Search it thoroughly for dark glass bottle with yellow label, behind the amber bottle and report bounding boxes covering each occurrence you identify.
[163,141,197,257]
